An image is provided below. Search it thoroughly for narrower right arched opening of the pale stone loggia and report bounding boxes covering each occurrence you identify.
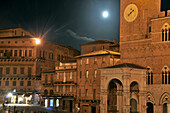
[130,82,139,113]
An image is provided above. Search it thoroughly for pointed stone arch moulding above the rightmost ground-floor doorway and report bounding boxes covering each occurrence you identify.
[159,92,170,105]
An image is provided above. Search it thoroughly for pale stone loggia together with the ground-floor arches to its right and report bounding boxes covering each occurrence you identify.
[100,65,170,113]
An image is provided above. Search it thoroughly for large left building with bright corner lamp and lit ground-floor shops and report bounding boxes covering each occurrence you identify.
[0,28,79,104]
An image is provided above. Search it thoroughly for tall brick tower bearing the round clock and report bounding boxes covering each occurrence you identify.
[120,0,162,63]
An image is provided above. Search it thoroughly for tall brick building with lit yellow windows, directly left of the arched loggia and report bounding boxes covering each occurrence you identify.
[76,40,120,113]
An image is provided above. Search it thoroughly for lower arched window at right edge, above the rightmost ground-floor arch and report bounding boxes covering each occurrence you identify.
[162,66,170,84]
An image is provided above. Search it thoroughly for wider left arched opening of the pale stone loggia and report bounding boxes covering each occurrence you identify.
[107,79,123,113]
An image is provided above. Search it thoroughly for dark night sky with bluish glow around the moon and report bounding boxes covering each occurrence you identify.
[0,0,170,49]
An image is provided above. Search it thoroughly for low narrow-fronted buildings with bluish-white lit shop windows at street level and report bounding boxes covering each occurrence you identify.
[41,60,77,112]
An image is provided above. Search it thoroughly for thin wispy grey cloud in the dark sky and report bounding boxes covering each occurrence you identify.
[67,29,95,41]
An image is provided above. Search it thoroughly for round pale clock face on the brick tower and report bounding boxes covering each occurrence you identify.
[124,4,138,22]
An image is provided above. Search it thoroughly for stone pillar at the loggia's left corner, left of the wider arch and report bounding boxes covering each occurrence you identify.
[100,89,107,113]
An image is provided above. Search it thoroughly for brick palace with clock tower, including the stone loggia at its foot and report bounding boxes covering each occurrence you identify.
[100,0,170,113]
